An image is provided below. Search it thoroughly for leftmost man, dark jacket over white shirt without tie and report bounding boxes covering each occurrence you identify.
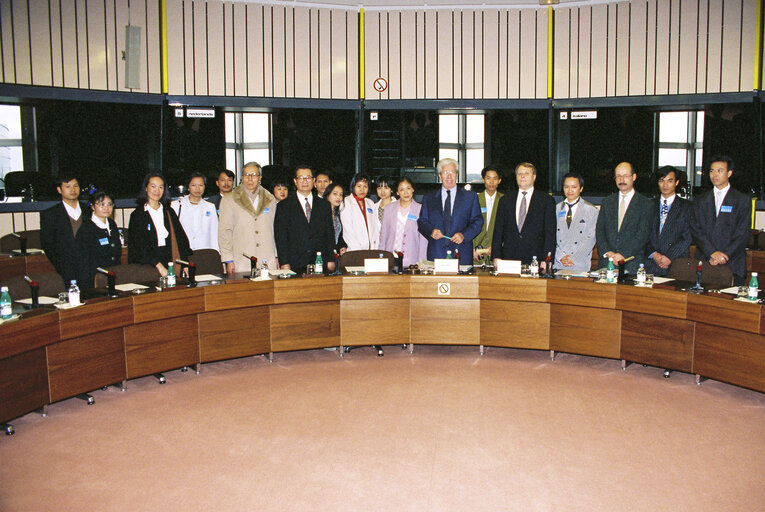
[40,176,91,286]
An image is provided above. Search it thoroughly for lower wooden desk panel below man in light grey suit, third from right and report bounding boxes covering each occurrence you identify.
[550,306,622,359]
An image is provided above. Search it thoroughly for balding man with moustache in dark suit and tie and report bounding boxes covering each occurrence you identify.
[596,162,652,275]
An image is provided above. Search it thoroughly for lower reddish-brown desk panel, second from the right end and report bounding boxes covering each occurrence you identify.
[621,311,694,372]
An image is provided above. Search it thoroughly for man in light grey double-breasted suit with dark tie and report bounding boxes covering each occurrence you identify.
[555,172,598,272]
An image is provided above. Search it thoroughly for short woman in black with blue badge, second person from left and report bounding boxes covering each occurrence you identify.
[75,190,122,290]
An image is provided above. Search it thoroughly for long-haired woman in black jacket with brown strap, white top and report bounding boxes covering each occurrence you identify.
[128,173,192,276]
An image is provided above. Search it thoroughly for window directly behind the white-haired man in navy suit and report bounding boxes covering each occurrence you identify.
[438,114,486,182]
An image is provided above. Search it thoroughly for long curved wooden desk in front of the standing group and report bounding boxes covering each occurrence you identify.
[0,275,765,421]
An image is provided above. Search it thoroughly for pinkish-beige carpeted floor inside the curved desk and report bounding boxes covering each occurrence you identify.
[0,346,765,512]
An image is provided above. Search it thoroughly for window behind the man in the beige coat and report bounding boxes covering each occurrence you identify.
[226,112,272,178]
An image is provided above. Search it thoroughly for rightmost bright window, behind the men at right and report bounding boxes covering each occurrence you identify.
[655,110,704,187]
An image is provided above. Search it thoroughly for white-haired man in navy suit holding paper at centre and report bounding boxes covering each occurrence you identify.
[417,158,483,265]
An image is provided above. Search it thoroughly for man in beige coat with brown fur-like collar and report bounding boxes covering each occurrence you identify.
[218,162,279,275]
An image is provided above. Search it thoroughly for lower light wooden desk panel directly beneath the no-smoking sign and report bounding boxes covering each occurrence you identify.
[411,298,481,345]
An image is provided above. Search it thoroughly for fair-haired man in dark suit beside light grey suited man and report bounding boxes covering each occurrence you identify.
[491,162,556,271]
